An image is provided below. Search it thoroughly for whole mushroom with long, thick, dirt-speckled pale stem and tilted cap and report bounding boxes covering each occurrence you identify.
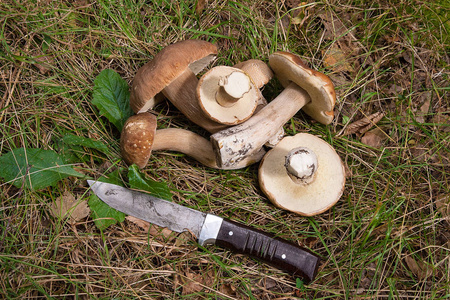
[211,52,336,168]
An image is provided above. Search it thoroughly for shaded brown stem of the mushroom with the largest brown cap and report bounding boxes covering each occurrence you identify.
[162,69,227,133]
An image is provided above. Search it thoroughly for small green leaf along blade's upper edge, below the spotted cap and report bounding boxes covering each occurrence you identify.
[128,165,172,201]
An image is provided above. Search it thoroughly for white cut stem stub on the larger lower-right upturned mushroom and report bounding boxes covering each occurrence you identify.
[284,147,319,185]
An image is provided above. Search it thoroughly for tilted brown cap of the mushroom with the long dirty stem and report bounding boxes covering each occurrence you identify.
[269,51,336,124]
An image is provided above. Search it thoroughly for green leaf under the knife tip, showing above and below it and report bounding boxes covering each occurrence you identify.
[88,170,125,230]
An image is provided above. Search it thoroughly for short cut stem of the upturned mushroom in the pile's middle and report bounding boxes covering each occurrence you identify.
[216,72,251,107]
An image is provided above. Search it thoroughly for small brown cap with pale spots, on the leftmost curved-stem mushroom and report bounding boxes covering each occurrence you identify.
[120,112,156,169]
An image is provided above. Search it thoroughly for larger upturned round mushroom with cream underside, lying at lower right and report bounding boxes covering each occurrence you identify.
[258,133,345,216]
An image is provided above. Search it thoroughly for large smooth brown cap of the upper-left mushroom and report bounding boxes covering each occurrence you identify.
[130,39,217,113]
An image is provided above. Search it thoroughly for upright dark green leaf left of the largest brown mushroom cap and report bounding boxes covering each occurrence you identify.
[92,69,133,131]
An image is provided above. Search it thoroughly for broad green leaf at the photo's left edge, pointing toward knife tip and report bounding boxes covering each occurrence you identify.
[0,148,84,190]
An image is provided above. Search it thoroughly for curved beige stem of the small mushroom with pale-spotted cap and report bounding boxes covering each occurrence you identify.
[153,128,218,169]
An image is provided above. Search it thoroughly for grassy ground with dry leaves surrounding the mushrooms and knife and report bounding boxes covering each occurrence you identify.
[0,0,450,299]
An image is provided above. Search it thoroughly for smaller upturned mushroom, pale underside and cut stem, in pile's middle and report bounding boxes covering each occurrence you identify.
[197,66,259,125]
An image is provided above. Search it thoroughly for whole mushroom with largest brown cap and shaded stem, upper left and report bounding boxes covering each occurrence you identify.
[130,39,226,132]
